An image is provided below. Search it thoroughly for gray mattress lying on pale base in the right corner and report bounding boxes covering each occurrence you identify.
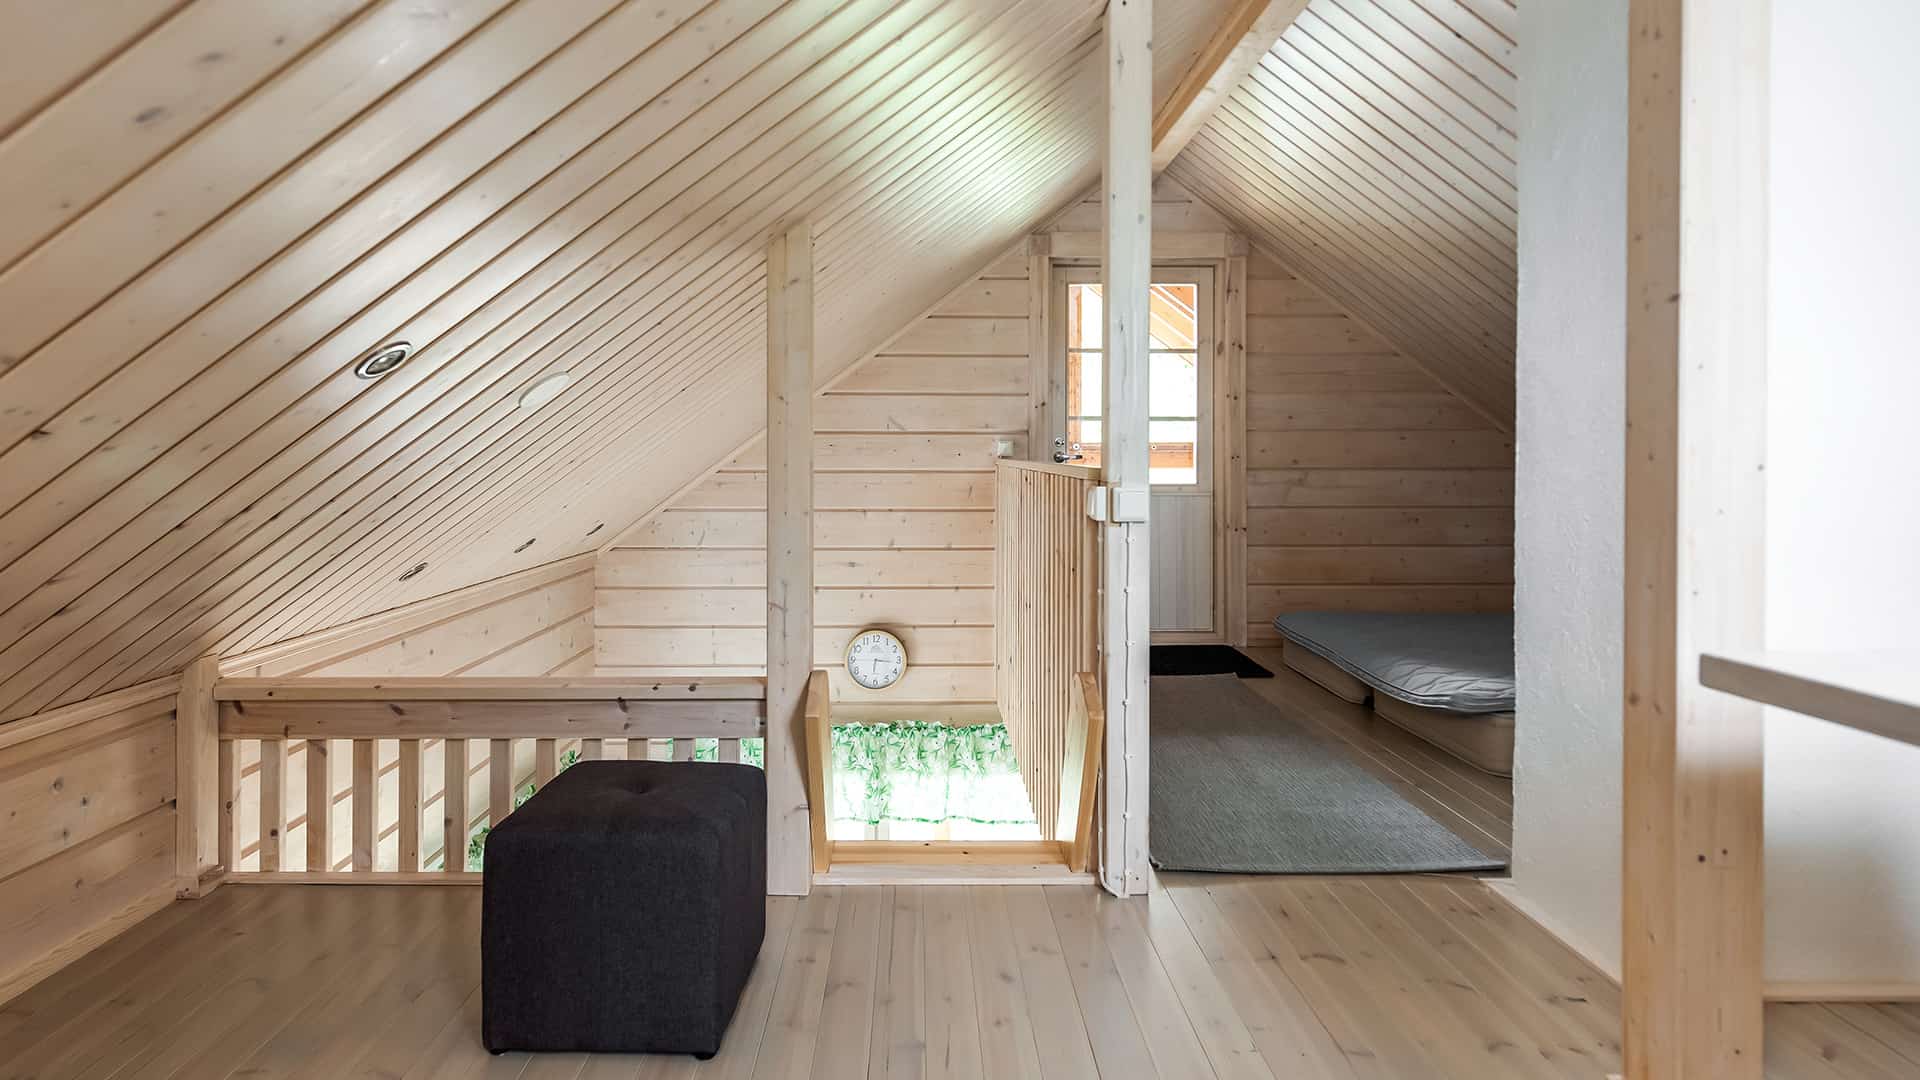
[1273,611,1513,713]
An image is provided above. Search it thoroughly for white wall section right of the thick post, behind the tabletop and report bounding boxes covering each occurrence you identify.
[1766,0,1920,982]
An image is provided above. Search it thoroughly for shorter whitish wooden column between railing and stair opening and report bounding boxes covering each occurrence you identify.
[766,225,814,896]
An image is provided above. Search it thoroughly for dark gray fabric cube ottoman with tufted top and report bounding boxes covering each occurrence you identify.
[480,761,766,1057]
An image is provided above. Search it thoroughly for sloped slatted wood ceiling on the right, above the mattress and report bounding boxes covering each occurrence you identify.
[1167,0,1517,430]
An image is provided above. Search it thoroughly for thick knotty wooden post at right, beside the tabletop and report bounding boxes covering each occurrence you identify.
[1622,0,1768,1080]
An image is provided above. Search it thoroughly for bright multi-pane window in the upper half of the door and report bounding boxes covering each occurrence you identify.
[1056,267,1212,488]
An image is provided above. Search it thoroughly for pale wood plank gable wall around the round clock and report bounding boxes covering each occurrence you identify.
[595,254,1029,705]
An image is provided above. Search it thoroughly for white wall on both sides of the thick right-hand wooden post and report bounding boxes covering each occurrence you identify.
[1513,0,1920,982]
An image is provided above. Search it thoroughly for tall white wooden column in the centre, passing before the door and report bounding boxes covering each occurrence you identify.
[1100,0,1154,896]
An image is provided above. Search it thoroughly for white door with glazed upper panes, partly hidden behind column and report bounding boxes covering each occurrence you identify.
[1050,263,1219,640]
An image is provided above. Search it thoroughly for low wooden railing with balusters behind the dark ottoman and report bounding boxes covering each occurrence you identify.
[213,678,766,882]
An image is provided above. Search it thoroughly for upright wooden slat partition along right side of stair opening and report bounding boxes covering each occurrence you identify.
[993,459,1100,840]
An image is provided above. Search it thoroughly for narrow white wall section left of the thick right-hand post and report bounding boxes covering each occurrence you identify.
[1513,0,1626,974]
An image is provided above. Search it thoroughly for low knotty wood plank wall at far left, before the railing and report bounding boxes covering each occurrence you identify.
[0,678,179,1001]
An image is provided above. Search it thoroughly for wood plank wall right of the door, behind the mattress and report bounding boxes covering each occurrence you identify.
[1246,252,1513,644]
